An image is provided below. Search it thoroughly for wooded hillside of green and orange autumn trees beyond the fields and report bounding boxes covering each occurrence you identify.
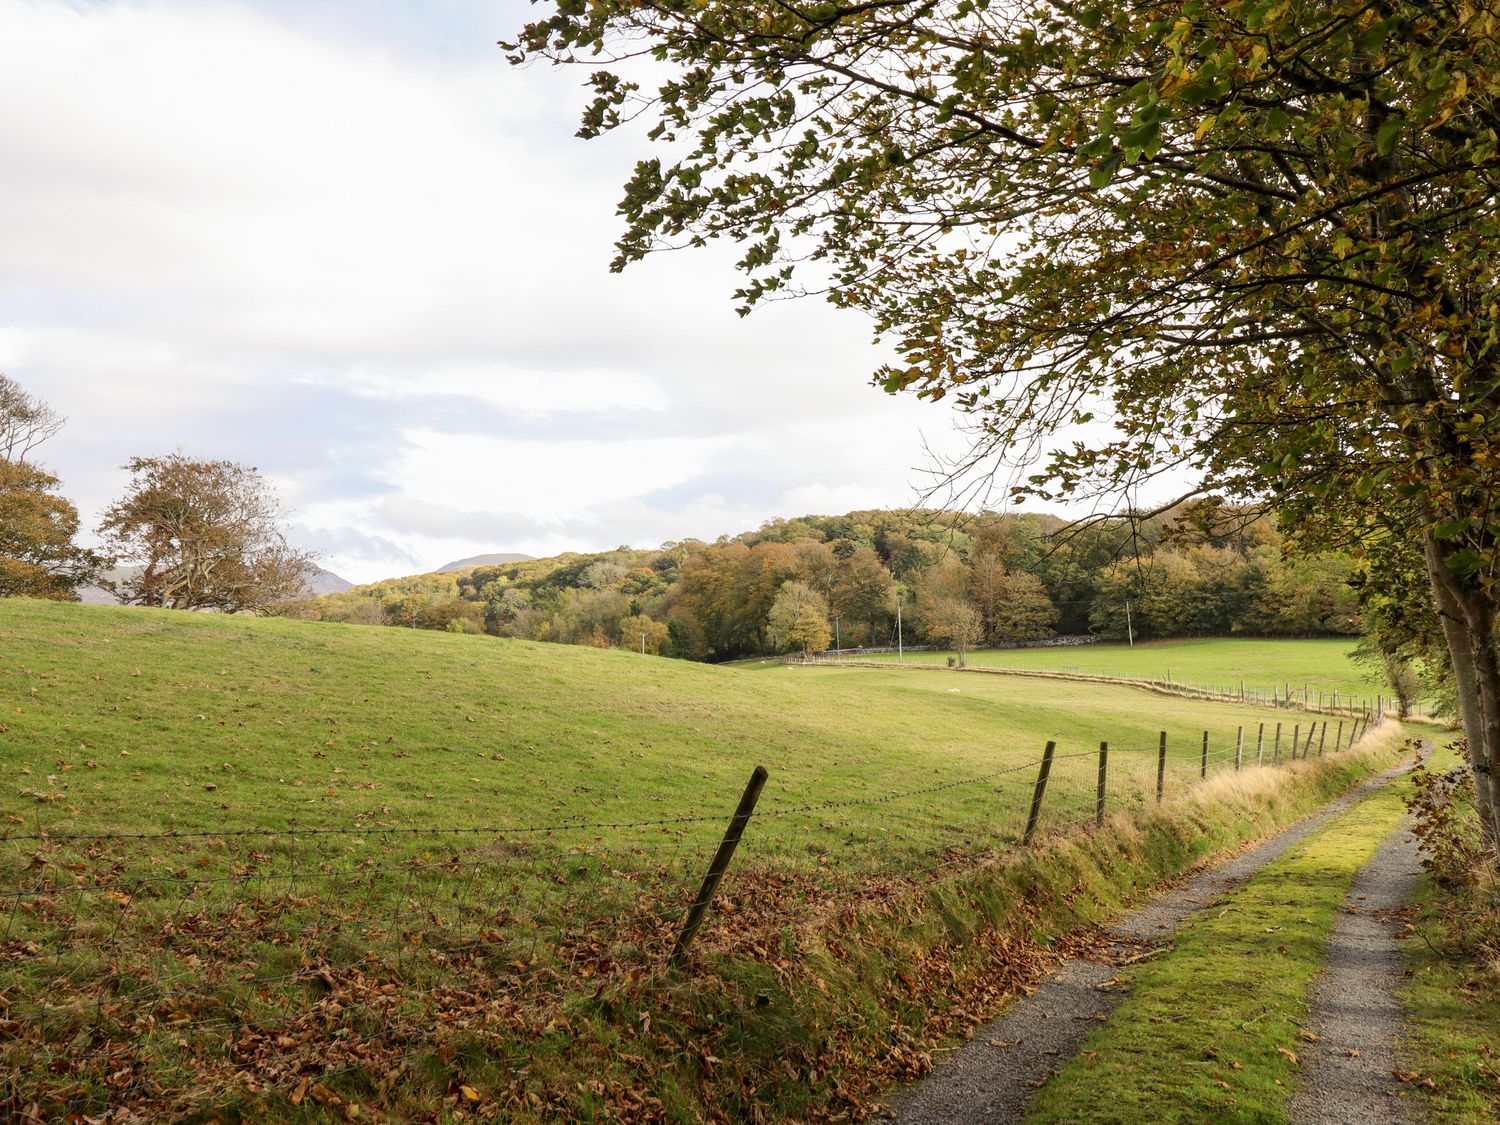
[282,506,1361,662]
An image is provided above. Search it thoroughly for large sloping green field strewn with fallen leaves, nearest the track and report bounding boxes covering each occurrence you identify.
[0,600,1380,1121]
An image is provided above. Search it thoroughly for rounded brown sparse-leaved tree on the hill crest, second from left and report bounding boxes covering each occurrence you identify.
[99,453,314,614]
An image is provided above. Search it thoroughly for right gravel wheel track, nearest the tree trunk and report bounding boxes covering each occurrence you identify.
[1292,824,1421,1125]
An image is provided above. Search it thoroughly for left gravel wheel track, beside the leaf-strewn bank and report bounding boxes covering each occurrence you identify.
[888,765,1407,1125]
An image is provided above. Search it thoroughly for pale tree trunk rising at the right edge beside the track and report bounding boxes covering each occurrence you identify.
[1424,531,1500,866]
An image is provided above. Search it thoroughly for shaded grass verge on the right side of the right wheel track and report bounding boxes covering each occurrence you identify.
[1401,753,1500,1125]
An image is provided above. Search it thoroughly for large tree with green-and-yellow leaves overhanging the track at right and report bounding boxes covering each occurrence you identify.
[507,0,1500,858]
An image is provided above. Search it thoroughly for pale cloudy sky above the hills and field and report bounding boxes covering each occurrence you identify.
[0,0,1092,582]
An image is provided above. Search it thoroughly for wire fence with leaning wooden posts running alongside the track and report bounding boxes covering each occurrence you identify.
[0,719,1368,1121]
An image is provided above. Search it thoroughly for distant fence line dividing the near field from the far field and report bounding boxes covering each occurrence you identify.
[788,650,1440,719]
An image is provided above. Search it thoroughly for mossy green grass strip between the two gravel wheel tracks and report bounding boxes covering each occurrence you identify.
[1028,741,1428,1122]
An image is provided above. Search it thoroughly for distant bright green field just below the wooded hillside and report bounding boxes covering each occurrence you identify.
[834,638,1386,698]
